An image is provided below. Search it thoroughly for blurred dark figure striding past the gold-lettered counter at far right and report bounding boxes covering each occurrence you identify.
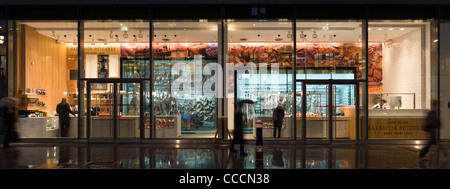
[419,100,441,161]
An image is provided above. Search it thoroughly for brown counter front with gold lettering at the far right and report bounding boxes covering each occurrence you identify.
[368,109,428,139]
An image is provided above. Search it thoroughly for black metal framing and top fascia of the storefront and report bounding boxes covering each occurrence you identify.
[4,4,442,141]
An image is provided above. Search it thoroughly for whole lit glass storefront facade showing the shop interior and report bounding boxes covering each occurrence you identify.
[0,4,450,143]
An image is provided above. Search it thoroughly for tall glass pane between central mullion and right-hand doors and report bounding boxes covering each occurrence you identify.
[224,19,295,139]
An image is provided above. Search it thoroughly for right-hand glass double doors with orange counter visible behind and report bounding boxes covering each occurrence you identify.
[297,82,358,140]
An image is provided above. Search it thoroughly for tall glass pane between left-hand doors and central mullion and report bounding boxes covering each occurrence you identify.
[152,19,222,138]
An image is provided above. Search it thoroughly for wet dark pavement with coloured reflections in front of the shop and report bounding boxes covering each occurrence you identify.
[0,144,450,169]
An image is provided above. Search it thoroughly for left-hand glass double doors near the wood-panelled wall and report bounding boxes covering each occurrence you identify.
[86,82,144,142]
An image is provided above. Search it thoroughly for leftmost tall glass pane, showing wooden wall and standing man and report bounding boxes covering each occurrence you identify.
[13,20,78,138]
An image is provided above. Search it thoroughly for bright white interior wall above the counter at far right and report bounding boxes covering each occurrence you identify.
[383,28,430,109]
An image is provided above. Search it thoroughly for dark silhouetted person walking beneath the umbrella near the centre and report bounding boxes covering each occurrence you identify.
[230,105,247,156]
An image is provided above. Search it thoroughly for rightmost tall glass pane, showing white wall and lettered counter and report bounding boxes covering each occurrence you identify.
[368,20,437,139]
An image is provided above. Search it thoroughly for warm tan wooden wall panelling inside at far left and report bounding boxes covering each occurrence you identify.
[17,25,68,114]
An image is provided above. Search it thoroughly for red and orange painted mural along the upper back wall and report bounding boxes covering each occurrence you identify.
[120,43,383,93]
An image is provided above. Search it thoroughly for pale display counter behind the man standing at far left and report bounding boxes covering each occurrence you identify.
[17,116,78,138]
